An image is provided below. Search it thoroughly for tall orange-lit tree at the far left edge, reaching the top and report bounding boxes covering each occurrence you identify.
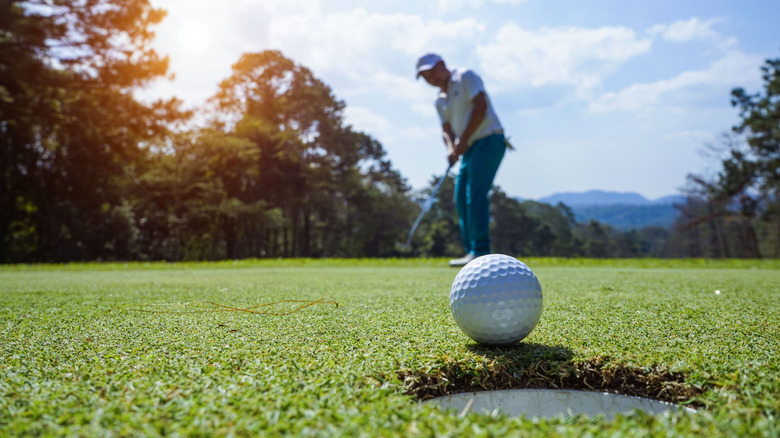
[0,0,181,261]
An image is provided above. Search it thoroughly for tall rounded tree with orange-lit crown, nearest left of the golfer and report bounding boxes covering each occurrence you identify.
[211,51,408,257]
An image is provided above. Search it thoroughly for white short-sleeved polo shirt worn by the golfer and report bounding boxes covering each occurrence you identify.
[436,69,502,146]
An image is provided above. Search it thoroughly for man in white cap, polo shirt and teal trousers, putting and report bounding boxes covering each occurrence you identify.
[417,53,511,266]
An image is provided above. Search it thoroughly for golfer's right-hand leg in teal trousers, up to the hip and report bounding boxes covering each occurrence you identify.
[468,135,506,255]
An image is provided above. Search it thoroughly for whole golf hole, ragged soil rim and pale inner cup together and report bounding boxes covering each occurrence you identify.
[397,354,704,420]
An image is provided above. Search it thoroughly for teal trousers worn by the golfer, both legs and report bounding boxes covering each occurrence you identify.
[455,134,506,256]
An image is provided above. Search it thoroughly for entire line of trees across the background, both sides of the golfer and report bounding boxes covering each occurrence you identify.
[0,0,780,263]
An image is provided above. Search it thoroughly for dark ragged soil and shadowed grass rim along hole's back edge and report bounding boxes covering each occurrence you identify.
[398,343,702,403]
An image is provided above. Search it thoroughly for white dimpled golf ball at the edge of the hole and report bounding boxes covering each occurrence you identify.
[450,254,542,345]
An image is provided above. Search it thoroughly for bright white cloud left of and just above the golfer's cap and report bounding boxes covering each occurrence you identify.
[269,8,484,121]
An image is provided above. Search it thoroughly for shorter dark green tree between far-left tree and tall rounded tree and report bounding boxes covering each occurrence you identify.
[132,130,281,260]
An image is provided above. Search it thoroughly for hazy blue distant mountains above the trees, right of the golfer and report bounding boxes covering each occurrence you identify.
[538,190,685,230]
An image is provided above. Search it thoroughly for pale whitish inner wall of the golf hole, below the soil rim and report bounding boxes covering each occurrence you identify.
[422,389,696,420]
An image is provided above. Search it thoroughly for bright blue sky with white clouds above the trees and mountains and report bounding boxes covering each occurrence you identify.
[142,0,780,199]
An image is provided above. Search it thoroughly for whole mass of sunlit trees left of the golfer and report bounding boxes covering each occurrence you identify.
[0,0,413,262]
